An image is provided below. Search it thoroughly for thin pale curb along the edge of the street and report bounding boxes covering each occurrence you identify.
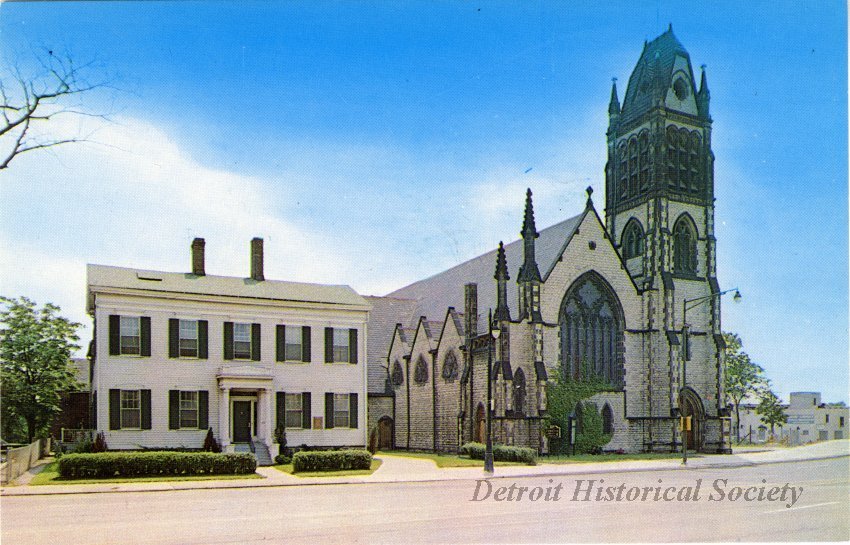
[0,454,850,498]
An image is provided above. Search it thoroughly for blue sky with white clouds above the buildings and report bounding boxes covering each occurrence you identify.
[0,1,848,401]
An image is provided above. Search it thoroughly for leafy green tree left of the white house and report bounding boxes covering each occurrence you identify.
[0,297,80,441]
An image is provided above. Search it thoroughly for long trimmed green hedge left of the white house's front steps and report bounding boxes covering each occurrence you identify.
[59,452,257,479]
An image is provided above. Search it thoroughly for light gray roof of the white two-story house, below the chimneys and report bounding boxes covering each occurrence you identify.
[88,265,369,310]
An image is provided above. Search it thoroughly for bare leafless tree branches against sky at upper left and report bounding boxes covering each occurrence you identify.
[0,50,111,170]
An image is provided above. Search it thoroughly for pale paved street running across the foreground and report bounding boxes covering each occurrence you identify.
[2,457,850,544]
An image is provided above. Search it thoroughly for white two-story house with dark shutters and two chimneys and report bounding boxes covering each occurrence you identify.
[88,238,370,463]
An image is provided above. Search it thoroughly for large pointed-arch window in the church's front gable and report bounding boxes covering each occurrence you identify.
[560,271,624,388]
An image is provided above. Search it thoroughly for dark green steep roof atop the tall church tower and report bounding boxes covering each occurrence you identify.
[621,26,693,122]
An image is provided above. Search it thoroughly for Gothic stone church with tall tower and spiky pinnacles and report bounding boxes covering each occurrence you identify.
[368,27,729,452]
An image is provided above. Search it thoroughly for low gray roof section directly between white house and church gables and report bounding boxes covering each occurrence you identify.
[366,296,416,394]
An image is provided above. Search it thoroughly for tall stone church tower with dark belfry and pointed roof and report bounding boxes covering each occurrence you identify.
[605,26,726,450]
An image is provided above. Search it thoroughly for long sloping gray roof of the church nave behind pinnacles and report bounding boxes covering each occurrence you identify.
[388,213,584,332]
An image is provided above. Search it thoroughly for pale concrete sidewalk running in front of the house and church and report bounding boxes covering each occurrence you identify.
[0,440,850,497]
